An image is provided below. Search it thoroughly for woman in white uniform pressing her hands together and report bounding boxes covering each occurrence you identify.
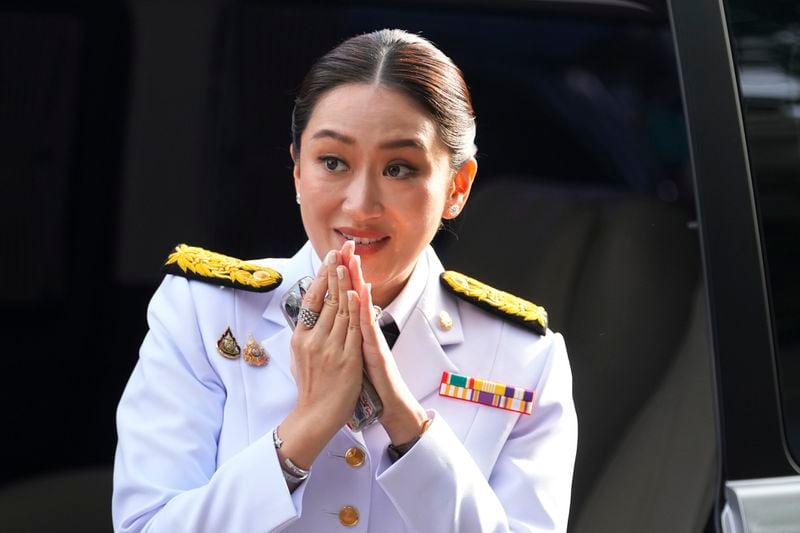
[113,30,577,532]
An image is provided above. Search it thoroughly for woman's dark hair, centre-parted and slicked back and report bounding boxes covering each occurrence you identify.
[292,30,477,168]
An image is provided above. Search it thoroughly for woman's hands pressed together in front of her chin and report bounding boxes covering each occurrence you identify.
[278,241,427,478]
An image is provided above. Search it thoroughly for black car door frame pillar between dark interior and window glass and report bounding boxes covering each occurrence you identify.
[669,0,800,528]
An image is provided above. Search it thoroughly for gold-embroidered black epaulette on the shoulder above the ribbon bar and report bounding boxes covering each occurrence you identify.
[439,270,547,335]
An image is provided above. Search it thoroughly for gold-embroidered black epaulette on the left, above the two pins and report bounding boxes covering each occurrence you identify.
[164,244,283,292]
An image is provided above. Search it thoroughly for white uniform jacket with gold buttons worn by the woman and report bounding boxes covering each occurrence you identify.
[113,243,577,533]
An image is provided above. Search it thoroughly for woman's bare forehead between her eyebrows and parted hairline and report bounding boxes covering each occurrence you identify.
[303,83,443,146]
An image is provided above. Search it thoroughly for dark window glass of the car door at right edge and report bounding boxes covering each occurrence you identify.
[728,0,800,462]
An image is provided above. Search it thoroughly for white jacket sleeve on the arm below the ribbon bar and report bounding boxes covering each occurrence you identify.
[377,333,578,532]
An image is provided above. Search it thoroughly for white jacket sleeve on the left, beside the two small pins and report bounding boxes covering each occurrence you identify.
[112,276,305,533]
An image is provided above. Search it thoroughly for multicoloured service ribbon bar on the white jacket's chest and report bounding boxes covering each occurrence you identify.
[439,371,536,415]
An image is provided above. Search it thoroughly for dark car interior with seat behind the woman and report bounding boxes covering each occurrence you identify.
[0,0,717,532]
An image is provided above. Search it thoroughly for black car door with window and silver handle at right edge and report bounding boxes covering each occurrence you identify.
[670,0,800,532]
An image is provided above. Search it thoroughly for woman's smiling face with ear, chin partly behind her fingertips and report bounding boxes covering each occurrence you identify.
[294,84,476,306]
